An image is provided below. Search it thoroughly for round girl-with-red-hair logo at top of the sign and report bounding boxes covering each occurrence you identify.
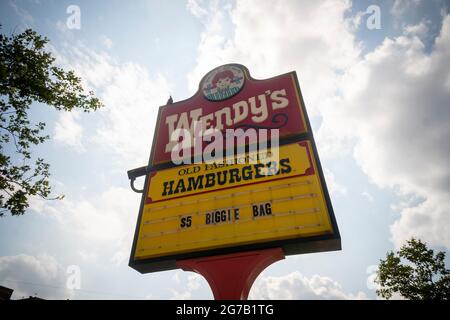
[202,65,245,101]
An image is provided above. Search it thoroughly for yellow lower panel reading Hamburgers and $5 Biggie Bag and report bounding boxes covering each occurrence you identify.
[134,141,333,260]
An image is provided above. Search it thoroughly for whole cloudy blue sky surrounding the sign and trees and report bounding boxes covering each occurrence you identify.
[0,0,450,299]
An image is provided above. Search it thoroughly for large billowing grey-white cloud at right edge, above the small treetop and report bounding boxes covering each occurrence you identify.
[320,16,450,248]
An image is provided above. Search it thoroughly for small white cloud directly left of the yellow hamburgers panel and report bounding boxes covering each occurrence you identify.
[30,187,139,265]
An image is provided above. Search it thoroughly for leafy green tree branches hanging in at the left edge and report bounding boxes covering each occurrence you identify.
[0,25,102,216]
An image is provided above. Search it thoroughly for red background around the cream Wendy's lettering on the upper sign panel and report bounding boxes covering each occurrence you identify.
[150,64,308,166]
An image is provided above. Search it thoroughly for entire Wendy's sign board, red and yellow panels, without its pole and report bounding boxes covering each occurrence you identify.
[129,64,341,273]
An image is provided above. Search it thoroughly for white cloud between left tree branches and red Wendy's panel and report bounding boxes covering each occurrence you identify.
[49,43,171,167]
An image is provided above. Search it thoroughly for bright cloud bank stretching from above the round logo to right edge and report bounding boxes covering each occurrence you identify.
[188,0,450,251]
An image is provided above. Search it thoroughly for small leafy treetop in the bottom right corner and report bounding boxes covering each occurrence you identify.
[376,238,450,300]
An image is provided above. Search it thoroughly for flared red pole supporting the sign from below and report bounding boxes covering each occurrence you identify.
[177,248,284,300]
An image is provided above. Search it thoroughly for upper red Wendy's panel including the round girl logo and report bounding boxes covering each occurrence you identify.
[150,64,307,165]
